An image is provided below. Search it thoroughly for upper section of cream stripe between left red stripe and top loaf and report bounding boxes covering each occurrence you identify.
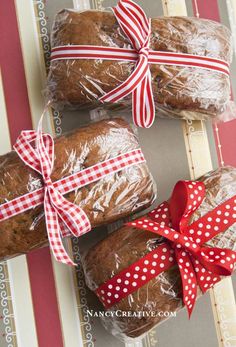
[15,0,53,132]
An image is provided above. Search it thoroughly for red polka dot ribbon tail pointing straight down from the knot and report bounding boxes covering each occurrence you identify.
[175,248,197,318]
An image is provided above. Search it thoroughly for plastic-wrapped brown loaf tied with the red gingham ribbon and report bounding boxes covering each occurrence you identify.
[0,119,156,260]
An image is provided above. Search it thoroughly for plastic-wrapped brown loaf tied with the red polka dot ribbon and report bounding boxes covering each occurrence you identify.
[83,167,236,337]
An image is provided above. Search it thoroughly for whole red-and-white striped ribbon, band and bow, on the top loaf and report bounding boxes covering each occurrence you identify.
[51,0,229,128]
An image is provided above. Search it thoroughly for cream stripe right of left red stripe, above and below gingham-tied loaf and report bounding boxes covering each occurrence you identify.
[15,0,90,347]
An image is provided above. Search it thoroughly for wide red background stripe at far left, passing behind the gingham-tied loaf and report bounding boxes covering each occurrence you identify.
[0,0,63,347]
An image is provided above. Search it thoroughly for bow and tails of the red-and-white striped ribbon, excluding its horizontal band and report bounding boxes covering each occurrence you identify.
[100,0,155,128]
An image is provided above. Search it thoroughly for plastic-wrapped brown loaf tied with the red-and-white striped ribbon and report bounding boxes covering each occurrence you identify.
[47,9,232,119]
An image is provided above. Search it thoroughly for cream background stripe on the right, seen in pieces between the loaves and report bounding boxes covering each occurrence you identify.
[162,0,236,347]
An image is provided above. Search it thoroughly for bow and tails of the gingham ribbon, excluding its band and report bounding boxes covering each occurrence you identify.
[14,117,91,265]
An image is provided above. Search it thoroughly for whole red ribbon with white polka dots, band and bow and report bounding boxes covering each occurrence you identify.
[97,181,236,316]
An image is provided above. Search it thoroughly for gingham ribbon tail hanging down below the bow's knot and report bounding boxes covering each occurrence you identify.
[44,189,76,265]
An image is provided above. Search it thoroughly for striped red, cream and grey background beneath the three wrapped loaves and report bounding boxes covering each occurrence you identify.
[0,0,236,347]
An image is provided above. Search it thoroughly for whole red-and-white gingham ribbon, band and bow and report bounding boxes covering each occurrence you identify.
[0,118,145,265]
